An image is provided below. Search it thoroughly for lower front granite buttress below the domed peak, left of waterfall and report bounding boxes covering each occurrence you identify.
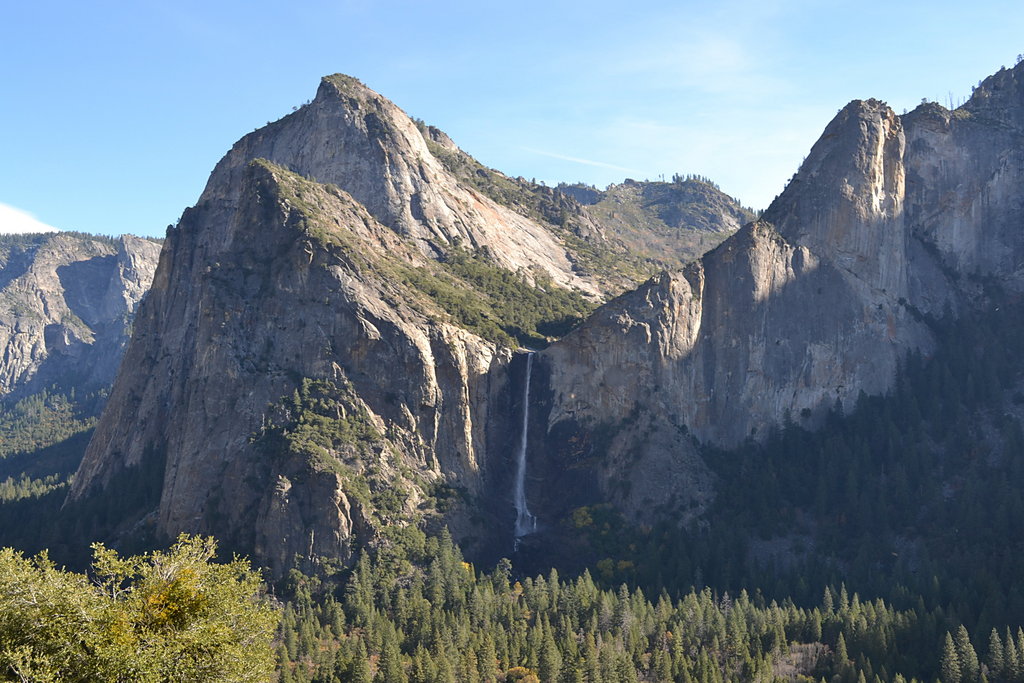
[72,162,520,572]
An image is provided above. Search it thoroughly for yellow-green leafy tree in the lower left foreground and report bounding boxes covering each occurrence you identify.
[0,536,279,683]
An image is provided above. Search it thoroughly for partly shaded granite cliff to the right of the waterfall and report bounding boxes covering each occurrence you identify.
[541,67,1024,519]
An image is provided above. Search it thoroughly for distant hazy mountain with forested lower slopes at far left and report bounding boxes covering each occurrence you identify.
[0,232,161,550]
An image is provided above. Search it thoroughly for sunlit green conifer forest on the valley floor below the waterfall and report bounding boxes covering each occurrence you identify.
[266,529,1024,683]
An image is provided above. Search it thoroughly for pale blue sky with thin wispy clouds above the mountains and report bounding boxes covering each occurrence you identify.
[0,0,1024,236]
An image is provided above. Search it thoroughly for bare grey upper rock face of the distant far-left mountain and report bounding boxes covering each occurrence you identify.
[0,232,160,399]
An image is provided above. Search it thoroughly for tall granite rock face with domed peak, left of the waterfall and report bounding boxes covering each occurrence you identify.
[70,76,638,573]
